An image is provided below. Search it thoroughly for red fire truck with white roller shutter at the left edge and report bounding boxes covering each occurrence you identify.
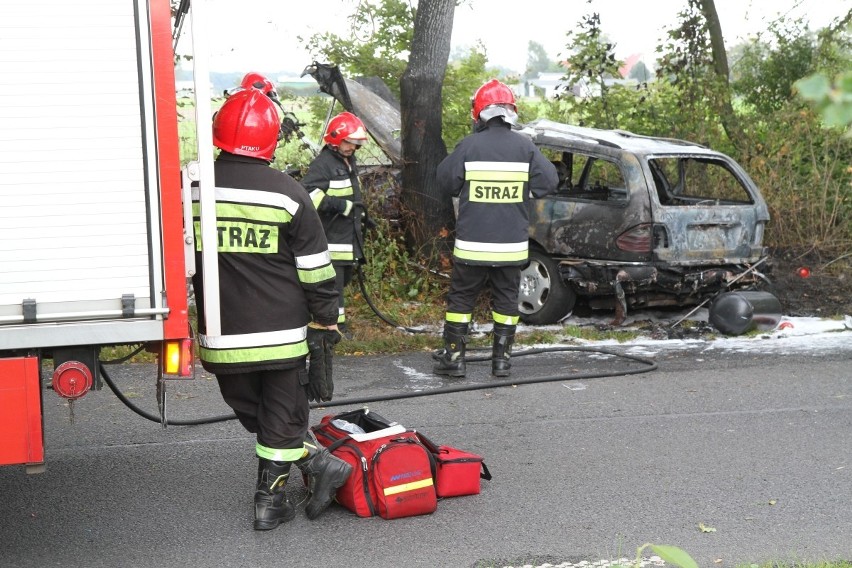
[0,0,216,473]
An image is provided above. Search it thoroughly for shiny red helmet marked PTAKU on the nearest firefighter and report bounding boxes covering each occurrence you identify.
[213,89,280,161]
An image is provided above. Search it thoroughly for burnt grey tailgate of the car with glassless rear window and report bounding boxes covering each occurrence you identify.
[647,154,769,266]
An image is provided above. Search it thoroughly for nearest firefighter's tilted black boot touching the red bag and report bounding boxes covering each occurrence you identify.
[295,430,352,519]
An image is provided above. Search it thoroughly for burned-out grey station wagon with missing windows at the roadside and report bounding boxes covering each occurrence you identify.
[519,120,769,324]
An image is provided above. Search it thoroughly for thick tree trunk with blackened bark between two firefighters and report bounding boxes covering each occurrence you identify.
[400,0,455,253]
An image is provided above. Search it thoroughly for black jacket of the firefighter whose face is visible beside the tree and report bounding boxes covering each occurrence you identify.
[301,149,364,265]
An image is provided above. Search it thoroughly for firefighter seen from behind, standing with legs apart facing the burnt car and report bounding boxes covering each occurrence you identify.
[434,79,558,377]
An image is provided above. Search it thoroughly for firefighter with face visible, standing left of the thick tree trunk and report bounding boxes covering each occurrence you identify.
[301,112,367,334]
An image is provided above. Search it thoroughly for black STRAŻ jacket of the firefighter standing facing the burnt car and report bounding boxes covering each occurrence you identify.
[437,118,559,266]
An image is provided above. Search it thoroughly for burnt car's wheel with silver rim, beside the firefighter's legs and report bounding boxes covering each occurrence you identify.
[518,250,577,325]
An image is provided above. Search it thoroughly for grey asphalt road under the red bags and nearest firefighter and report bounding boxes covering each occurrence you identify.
[0,332,852,568]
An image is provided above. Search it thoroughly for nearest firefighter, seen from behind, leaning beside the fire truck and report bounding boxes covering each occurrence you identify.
[193,89,351,530]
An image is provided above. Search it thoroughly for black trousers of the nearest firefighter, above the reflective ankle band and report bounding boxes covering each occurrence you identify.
[216,367,310,450]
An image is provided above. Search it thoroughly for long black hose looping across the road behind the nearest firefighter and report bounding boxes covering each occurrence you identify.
[100,347,657,426]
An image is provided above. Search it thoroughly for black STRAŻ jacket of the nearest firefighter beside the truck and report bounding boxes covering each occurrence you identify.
[192,152,337,374]
